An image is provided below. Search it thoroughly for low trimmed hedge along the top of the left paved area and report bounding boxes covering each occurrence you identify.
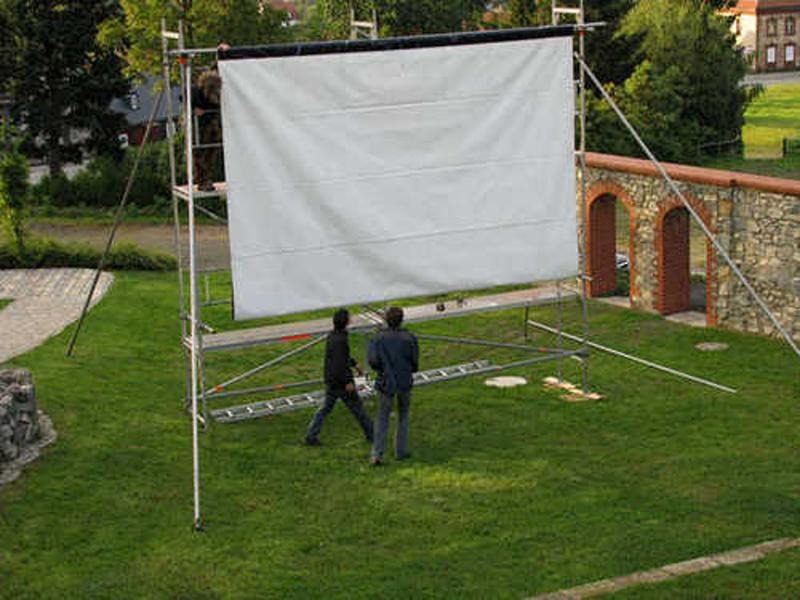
[0,238,177,271]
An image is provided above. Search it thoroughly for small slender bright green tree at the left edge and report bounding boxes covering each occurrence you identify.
[0,126,29,255]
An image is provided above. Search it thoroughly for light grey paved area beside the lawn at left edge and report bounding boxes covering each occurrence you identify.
[0,269,114,363]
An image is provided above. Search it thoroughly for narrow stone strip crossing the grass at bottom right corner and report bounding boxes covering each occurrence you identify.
[529,538,800,600]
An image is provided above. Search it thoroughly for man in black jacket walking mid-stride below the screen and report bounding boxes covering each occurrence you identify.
[305,308,372,446]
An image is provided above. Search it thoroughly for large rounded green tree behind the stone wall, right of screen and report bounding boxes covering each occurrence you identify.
[588,0,750,162]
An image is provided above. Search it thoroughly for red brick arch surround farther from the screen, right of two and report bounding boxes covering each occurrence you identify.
[655,194,717,327]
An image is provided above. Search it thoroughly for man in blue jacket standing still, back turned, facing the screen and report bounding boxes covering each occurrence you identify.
[367,306,419,466]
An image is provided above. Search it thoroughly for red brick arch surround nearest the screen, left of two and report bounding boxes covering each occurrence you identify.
[585,179,639,303]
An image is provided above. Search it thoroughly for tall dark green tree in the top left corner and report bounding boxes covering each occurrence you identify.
[2,0,129,176]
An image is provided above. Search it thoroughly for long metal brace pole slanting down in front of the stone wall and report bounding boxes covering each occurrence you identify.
[575,53,800,358]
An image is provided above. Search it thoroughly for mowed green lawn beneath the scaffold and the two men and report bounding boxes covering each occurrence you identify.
[0,273,800,599]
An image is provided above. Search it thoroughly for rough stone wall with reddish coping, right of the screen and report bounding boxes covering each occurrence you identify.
[578,153,800,339]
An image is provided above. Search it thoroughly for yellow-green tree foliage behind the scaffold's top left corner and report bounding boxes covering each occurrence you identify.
[98,0,291,77]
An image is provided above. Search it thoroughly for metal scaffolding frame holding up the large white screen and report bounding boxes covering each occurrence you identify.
[155,16,774,530]
